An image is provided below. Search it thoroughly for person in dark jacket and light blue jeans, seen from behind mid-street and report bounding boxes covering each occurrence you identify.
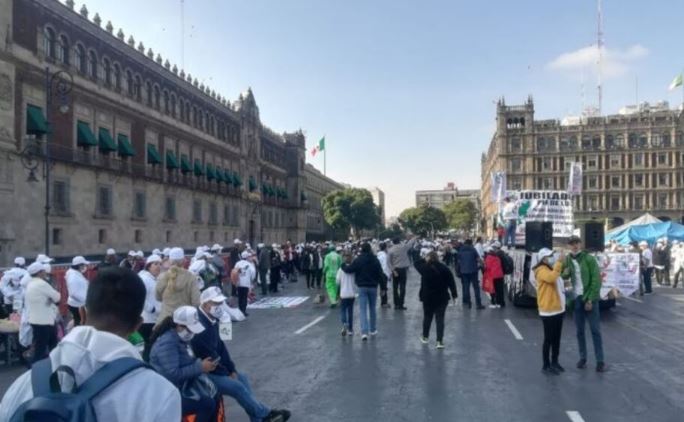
[342,242,383,340]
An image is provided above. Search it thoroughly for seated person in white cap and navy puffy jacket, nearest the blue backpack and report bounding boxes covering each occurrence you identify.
[150,306,218,422]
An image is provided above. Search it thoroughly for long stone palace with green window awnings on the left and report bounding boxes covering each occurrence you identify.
[0,0,328,264]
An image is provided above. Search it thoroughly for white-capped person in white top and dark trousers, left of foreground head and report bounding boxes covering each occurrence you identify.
[24,261,62,363]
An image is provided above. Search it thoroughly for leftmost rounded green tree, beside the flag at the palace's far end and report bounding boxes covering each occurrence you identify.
[321,188,380,237]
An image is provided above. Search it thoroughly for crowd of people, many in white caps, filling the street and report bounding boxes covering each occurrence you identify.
[5,231,684,421]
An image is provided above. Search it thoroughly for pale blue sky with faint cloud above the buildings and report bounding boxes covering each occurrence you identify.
[81,0,684,217]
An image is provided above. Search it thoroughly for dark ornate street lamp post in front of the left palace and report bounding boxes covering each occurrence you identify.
[21,67,74,256]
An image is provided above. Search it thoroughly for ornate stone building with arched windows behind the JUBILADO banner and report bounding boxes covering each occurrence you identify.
[481,98,684,239]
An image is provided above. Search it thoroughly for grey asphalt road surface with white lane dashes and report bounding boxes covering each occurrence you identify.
[0,271,684,422]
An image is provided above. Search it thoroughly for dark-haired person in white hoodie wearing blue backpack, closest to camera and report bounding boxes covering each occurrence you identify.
[0,267,181,422]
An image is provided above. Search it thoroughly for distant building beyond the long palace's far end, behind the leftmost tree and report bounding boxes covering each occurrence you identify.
[304,164,348,241]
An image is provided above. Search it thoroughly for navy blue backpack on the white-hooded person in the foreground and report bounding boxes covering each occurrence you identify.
[10,358,149,422]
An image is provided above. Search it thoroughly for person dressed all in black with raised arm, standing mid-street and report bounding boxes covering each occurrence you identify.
[413,251,458,349]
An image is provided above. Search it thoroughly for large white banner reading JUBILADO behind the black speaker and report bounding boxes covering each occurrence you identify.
[514,190,573,241]
